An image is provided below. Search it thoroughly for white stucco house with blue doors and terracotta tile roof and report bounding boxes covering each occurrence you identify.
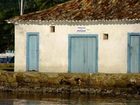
[8,0,140,73]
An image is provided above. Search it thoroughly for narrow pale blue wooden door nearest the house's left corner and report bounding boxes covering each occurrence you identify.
[27,33,39,71]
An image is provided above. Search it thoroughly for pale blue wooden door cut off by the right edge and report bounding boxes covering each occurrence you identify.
[128,35,140,73]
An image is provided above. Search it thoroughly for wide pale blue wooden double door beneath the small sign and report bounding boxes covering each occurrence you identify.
[69,35,97,73]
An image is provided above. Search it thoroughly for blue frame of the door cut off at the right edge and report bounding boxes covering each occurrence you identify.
[127,32,140,73]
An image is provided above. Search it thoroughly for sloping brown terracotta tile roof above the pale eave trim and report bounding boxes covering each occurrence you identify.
[9,0,140,21]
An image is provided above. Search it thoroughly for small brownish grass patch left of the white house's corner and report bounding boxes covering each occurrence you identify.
[0,63,14,71]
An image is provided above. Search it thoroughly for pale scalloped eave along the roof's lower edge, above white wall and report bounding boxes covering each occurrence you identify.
[7,19,140,25]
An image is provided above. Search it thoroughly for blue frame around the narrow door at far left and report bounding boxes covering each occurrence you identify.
[26,32,39,71]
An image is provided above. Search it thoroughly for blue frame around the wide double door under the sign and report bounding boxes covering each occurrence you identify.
[68,34,98,73]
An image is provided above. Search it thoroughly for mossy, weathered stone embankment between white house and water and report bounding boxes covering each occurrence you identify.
[0,72,140,98]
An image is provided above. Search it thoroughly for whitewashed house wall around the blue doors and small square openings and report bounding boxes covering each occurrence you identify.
[15,24,140,73]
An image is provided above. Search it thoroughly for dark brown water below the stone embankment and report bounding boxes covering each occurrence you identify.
[0,94,140,105]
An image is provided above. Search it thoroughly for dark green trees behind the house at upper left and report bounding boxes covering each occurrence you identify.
[0,0,68,53]
